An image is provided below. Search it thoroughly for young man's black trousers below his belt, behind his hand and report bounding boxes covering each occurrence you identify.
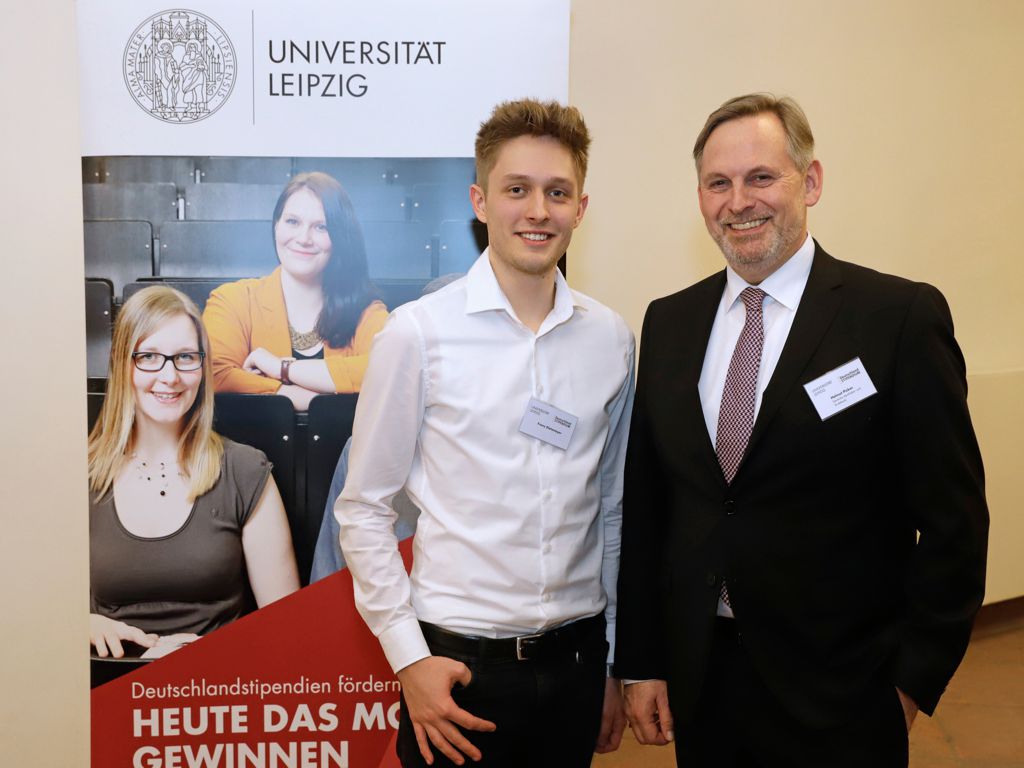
[397,615,608,768]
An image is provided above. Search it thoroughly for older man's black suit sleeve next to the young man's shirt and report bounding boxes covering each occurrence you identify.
[614,302,669,680]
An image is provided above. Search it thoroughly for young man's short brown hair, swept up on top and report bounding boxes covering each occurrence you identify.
[476,98,590,188]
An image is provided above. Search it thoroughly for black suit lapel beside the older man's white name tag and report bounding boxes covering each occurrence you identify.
[746,242,843,455]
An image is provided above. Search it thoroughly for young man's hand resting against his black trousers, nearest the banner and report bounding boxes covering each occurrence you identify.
[398,656,497,765]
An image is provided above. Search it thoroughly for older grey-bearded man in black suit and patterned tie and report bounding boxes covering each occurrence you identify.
[615,94,988,768]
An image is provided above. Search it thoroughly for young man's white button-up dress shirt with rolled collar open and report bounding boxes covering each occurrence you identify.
[335,251,634,672]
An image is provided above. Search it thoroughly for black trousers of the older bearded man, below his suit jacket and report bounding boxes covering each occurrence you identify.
[675,618,908,768]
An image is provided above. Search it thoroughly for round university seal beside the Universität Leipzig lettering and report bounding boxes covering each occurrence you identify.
[124,9,236,123]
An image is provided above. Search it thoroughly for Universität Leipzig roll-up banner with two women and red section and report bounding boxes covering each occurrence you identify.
[77,0,569,768]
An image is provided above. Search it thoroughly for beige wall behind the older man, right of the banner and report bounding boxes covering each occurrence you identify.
[569,0,1024,602]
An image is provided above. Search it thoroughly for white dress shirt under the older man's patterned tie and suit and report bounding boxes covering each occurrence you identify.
[697,234,814,616]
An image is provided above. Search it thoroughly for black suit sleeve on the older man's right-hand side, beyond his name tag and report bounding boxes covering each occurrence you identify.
[892,285,988,715]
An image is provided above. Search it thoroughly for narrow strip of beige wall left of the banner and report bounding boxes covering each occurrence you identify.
[0,0,89,768]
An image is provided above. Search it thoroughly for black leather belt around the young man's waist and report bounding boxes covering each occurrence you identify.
[420,613,604,662]
